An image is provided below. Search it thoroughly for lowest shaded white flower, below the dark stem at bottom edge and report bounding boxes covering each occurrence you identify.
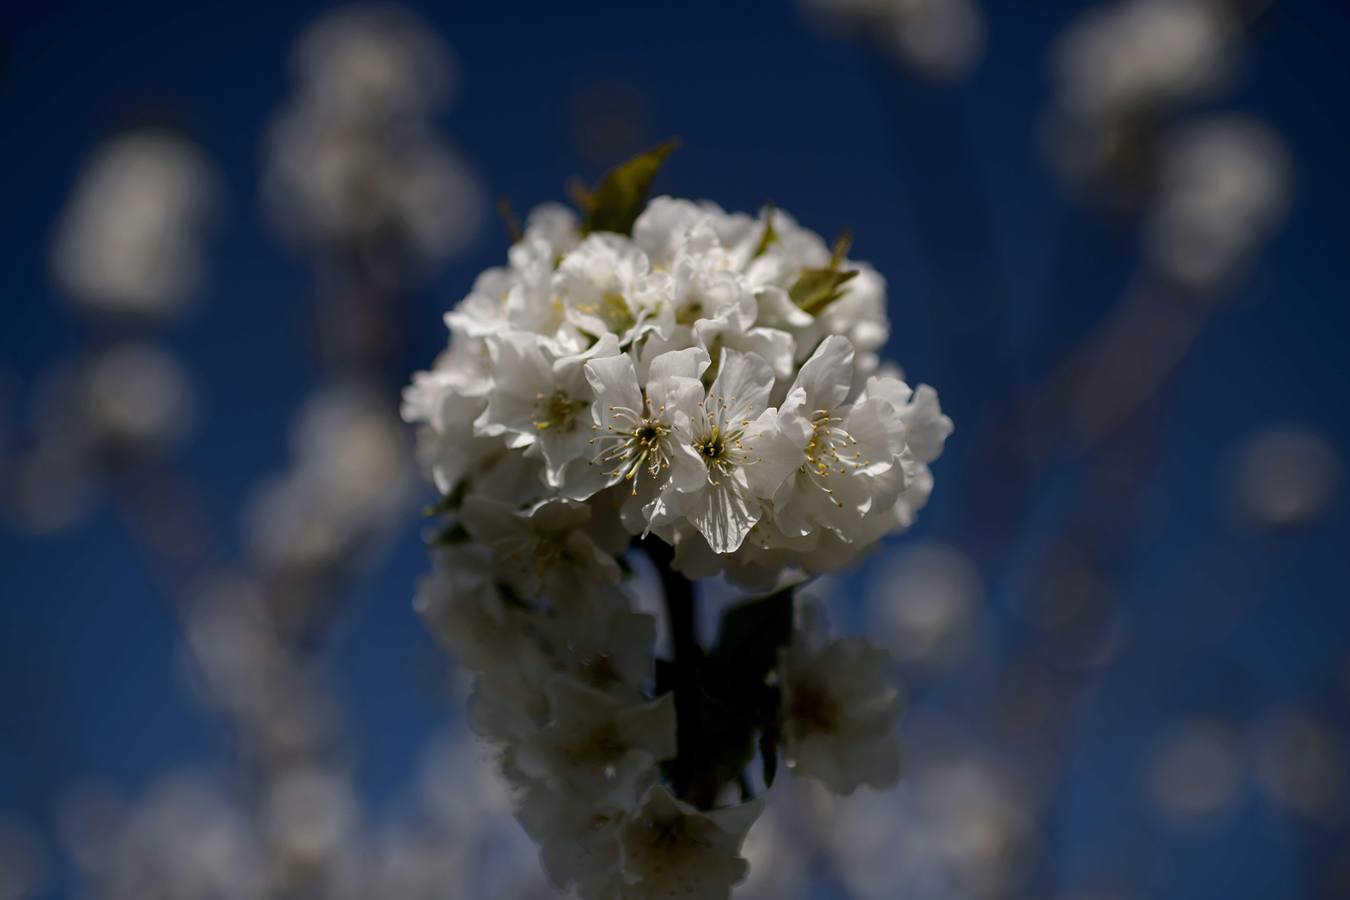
[618,784,764,900]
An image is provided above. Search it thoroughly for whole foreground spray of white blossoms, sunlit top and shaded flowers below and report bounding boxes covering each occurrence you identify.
[404,147,952,899]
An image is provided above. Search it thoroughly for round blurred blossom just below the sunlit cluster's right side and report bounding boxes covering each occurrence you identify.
[867,542,983,665]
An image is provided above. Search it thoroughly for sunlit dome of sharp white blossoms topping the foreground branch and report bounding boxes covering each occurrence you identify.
[404,197,952,595]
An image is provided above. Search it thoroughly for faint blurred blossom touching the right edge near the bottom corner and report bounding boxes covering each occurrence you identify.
[1257,712,1350,824]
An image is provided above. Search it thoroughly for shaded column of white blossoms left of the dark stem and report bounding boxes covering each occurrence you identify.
[417,534,761,900]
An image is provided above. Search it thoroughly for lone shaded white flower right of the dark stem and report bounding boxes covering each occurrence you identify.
[782,607,900,793]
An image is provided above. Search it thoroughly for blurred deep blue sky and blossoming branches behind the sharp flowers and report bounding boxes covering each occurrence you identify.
[0,0,1350,900]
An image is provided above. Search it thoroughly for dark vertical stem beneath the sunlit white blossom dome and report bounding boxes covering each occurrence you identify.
[641,537,716,808]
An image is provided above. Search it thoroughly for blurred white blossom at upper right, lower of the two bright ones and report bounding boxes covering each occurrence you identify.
[1146,116,1291,290]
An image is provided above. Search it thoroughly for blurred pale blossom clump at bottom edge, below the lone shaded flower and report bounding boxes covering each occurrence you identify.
[825,754,1034,900]
